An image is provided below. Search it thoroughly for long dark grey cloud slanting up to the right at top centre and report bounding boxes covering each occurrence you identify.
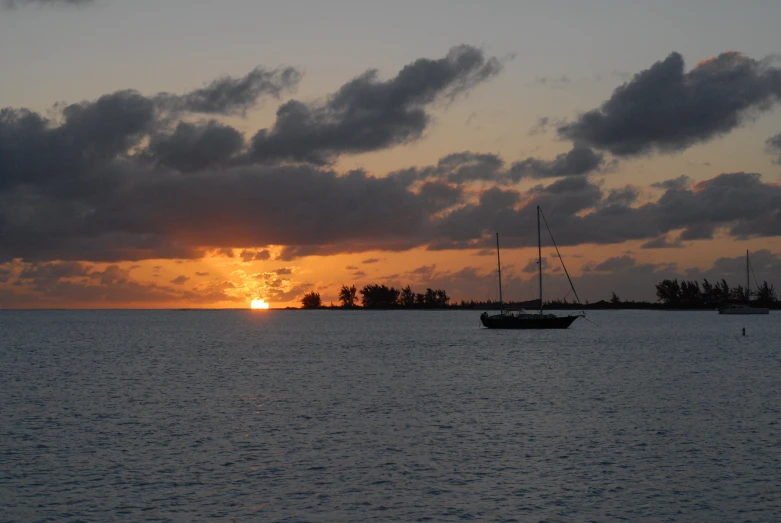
[250,45,501,164]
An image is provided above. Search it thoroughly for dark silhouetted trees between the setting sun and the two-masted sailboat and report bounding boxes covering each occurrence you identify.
[301,283,450,309]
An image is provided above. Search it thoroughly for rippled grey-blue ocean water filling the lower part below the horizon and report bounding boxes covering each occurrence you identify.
[0,311,781,522]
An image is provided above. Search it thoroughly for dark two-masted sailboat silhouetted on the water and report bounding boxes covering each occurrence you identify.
[480,205,586,329]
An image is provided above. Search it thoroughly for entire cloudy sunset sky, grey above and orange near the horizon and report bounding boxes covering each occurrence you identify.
[0,0,781,308]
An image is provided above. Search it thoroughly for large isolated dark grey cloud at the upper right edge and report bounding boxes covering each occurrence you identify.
[558,51,781,156]
